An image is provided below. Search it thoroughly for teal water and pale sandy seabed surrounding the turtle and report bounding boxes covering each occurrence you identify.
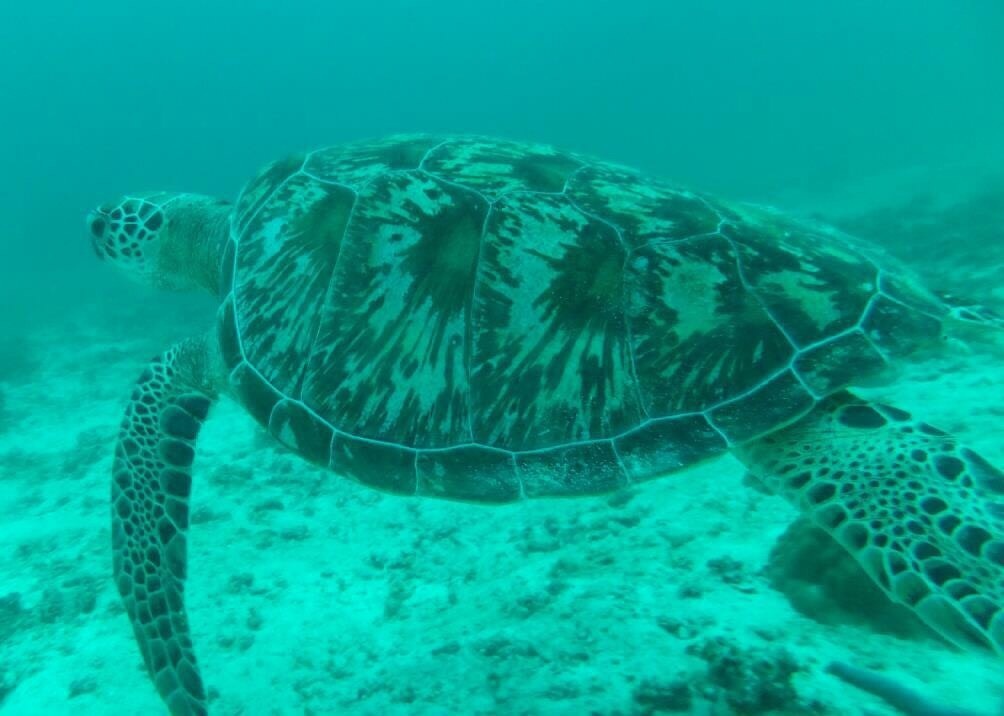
[0,0,1004,715]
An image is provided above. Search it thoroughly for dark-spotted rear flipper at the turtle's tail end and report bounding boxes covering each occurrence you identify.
[736,393,1004,655]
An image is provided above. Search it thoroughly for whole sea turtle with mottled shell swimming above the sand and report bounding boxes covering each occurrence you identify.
[87,136,1004,714]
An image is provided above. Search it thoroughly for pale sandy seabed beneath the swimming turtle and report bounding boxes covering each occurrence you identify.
[0,309,1004,716]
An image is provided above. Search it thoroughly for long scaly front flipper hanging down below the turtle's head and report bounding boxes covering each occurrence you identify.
[111,339,215,716]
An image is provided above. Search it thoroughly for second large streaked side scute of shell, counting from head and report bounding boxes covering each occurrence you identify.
[300,171,488,447]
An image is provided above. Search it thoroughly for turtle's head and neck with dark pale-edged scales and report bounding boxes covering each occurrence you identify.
[87,192,230,292]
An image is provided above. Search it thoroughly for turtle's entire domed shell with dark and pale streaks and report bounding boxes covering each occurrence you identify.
[220,136,943,501]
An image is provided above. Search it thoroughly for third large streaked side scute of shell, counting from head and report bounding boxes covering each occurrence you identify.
[471,189,642,450]
